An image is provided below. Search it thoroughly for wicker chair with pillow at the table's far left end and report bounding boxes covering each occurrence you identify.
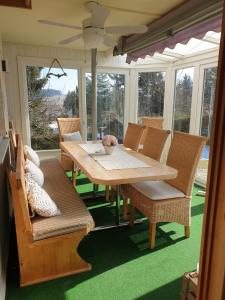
[57,118,81,185]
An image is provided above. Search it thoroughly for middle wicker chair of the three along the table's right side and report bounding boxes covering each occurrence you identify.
[121,127,170,220]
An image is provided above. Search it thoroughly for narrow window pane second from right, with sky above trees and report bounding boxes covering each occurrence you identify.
[173,67,194,132]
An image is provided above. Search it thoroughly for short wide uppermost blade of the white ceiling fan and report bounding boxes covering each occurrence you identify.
[85,1,110,28]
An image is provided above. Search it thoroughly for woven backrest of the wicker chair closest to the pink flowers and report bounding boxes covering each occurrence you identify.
[123,123,145,151]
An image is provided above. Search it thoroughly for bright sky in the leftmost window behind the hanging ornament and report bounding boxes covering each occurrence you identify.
[41,68,78,95]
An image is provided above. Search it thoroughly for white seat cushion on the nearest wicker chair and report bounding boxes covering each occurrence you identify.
[132,181,185,200]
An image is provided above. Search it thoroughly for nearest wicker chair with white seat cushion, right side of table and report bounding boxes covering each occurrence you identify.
[127,132,206,249]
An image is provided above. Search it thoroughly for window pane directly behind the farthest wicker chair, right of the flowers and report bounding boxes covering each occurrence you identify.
[138,72,165,121]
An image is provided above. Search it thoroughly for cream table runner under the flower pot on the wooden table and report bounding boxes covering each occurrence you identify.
[79,143,151,171]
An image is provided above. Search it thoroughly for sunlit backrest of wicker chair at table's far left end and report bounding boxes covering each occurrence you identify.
[57,118,81,142]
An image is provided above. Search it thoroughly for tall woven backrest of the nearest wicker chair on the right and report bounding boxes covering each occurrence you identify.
[167,131,206,196]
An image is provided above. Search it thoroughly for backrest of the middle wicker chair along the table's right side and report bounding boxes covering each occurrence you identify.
[141,127,170,160]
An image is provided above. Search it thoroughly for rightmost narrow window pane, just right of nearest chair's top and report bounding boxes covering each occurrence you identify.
[200,67,217,159]
